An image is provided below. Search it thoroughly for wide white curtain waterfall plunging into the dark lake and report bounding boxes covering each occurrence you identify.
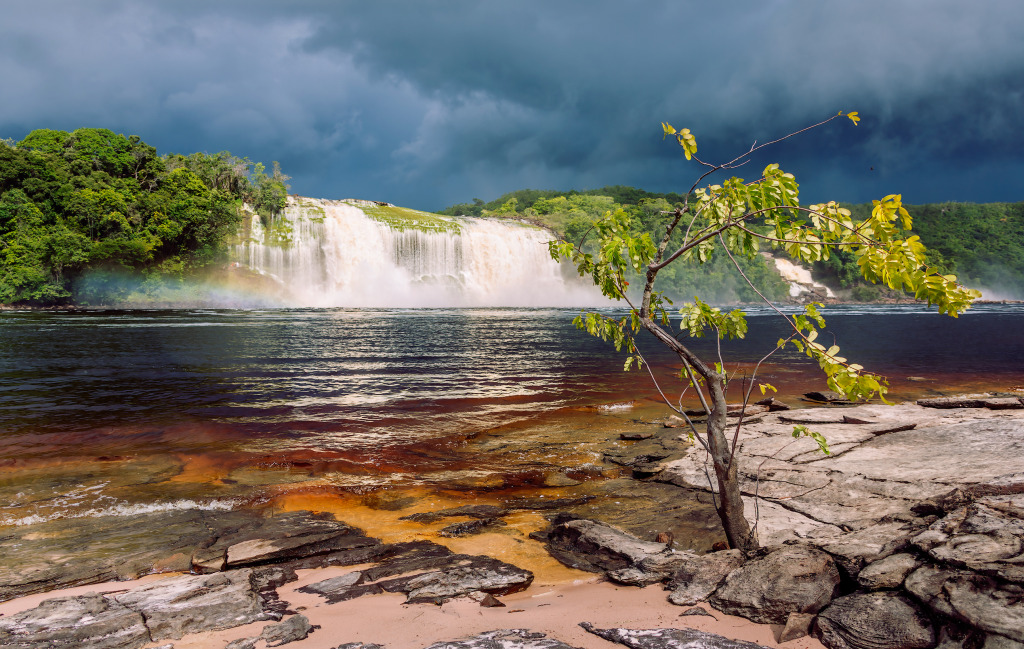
[233,197,607,307]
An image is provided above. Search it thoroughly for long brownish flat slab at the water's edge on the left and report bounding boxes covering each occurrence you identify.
[0,510,381,601]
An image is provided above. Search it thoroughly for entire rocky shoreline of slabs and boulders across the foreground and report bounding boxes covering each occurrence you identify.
[0,395,1024,649]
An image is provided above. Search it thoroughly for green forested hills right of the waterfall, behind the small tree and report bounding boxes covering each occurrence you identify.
[441,185,1024,302]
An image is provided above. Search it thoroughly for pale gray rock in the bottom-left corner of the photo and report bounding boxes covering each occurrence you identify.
[0,593,152,649]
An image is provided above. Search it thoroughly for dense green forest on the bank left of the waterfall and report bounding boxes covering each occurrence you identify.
[0,128,288,305]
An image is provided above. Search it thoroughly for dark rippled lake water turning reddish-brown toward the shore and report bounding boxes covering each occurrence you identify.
[0,305,1024,525]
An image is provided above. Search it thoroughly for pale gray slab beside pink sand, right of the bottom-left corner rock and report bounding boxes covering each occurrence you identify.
[114,569,269,640]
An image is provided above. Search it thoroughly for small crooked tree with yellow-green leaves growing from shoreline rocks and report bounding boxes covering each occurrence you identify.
[550,112,981,550]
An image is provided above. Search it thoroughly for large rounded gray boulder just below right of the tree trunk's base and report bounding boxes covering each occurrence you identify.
[710,546,840,624]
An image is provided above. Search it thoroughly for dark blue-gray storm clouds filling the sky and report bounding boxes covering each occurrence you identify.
[0,0,1024,209]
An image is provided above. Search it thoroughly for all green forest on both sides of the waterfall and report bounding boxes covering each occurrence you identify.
[0,128,1024,305]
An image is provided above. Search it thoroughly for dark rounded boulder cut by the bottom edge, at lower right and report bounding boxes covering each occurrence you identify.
[815,593,935,649]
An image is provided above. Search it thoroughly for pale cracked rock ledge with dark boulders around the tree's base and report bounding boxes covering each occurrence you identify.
[539,399,1024,649]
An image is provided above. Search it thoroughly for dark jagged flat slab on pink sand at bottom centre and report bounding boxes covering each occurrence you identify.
[299,542,534,604]
